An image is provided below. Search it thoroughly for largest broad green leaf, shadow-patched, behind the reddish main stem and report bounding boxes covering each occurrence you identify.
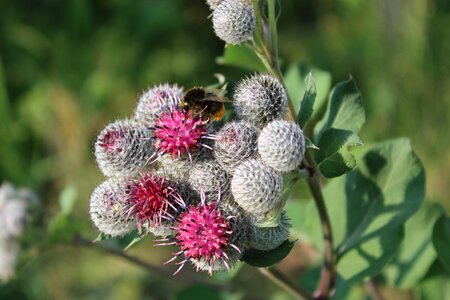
[288,139,425,282]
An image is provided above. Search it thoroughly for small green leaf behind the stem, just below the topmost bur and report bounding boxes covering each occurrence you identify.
[216,44,266,72]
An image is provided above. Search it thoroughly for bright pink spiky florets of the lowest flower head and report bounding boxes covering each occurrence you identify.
[161,193,241,275]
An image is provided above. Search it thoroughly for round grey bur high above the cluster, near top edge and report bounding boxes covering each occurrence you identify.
[212,0,256,45]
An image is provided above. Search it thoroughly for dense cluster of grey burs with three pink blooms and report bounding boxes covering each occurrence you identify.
[90,74,305,273]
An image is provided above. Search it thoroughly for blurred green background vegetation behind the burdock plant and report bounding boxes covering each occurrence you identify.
[0,0,450,299]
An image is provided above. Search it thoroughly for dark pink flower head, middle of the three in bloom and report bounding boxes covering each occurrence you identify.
[129,173,185,231]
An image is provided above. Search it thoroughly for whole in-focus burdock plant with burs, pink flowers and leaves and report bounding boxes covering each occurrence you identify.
[85,0,440,299]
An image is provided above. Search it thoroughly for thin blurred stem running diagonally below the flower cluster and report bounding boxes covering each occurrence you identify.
[74,235,232,290]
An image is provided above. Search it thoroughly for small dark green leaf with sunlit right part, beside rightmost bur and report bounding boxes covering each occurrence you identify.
[316,128,363,178]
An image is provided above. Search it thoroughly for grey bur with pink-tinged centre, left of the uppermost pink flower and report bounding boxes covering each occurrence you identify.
[95,120,154,177]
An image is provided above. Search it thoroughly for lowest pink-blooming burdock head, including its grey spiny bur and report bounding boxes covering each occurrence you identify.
[161,193,247,275]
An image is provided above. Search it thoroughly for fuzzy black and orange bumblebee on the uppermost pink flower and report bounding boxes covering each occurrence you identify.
[181,87,231,121]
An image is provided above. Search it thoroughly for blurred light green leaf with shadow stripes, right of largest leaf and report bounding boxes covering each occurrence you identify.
[383,201,442,289]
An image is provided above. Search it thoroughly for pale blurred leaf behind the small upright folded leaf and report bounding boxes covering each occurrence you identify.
[284,63,331,117]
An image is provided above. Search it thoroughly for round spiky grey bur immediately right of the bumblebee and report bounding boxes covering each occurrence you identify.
[233,74,288,128]
